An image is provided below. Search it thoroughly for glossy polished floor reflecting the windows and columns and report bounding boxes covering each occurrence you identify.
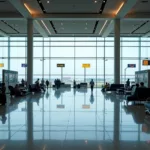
[0,89,150,150]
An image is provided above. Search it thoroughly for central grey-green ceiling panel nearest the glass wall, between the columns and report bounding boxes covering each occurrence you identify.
[53,21,96,34]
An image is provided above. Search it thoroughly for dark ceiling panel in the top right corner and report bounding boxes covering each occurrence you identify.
[131,0,150,13]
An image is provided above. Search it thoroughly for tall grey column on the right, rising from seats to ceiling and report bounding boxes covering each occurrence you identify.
[114,19,120,84]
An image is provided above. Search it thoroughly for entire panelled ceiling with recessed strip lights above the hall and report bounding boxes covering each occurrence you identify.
[0,0,150,37]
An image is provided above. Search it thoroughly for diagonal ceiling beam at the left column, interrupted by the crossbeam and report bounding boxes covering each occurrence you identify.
[9,0,48,37]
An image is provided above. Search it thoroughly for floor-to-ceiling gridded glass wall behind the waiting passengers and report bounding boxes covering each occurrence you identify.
[0,37,150,87]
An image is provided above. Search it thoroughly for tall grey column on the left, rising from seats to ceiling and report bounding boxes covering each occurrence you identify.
[27,19,33,85]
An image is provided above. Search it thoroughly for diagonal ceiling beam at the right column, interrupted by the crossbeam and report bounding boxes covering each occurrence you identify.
[102,0,138,37]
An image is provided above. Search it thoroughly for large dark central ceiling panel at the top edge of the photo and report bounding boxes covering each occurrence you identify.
[38,0,103,13]
